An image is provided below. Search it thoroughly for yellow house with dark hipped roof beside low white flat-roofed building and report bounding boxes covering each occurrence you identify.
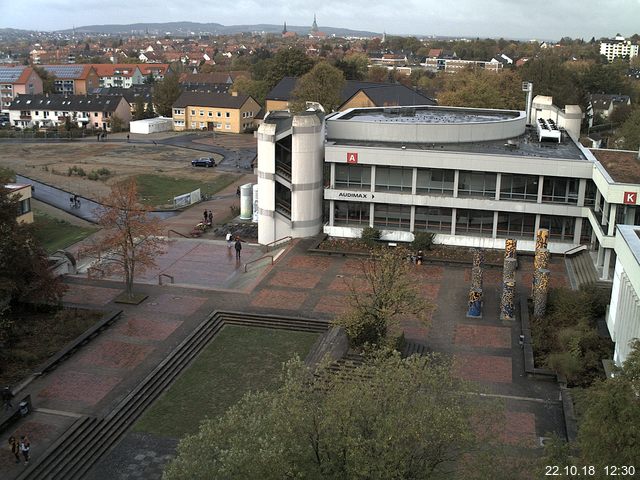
[173,92,260,133]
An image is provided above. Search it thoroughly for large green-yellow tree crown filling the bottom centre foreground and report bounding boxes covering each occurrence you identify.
[163,353,502,480]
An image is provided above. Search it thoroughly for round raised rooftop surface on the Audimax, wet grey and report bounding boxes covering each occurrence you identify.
[332,105,520,125]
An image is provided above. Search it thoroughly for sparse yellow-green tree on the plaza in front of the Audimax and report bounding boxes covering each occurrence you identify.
[334,249,431,347]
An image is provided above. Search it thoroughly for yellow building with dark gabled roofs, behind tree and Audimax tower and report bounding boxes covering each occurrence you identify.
[265,77,436,111]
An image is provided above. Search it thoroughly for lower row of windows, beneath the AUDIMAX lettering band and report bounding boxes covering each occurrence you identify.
[333,201,575,242]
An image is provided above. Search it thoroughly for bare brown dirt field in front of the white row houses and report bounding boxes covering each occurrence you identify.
[0,142,228,199]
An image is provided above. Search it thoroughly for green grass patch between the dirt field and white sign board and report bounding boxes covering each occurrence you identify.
[136,173,237,207]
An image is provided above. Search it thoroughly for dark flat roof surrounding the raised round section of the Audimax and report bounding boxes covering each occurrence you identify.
[329,127,588,161]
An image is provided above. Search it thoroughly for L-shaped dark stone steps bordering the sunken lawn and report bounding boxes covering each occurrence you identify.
[18,312,328,480]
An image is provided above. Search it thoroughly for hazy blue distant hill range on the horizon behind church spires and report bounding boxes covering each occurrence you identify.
[61,22,379,37]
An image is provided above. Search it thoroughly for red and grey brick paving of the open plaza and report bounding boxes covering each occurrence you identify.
[0,237,566,480]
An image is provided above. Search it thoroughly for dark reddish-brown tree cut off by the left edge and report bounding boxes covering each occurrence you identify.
[0,179,66,342]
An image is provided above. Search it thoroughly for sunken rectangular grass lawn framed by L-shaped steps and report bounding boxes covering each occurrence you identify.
[133,325,318,438]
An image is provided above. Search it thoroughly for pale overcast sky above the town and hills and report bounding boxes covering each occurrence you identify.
[5,0,640,40]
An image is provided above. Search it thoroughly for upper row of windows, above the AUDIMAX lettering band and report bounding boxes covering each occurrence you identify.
[334,163,584,205]
